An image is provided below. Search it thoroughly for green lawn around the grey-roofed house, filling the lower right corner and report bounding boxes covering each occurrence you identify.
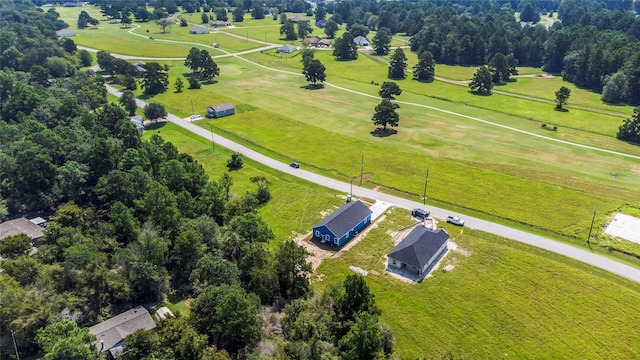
[314,209,640,359]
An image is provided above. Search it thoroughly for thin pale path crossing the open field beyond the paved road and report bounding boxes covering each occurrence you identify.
[225,51,640,160]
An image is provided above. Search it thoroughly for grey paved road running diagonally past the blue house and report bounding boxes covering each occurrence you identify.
[106,85,640,283]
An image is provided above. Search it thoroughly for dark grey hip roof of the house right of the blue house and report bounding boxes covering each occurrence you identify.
[388,226,449,269]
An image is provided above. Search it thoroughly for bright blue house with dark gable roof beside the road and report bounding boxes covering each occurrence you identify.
[313,201,372,246]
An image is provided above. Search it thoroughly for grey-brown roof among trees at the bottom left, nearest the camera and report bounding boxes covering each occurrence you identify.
[89,306,156,351]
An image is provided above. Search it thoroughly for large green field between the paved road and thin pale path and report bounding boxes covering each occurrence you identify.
[145,59,640,243]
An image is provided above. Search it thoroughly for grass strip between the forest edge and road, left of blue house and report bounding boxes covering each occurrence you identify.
[143,123,344,246]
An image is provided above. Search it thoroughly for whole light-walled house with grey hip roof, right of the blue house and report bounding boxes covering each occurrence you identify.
[387,226,449,275]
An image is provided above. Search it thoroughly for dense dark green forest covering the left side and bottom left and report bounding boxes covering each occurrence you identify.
[0,0,393,359]
